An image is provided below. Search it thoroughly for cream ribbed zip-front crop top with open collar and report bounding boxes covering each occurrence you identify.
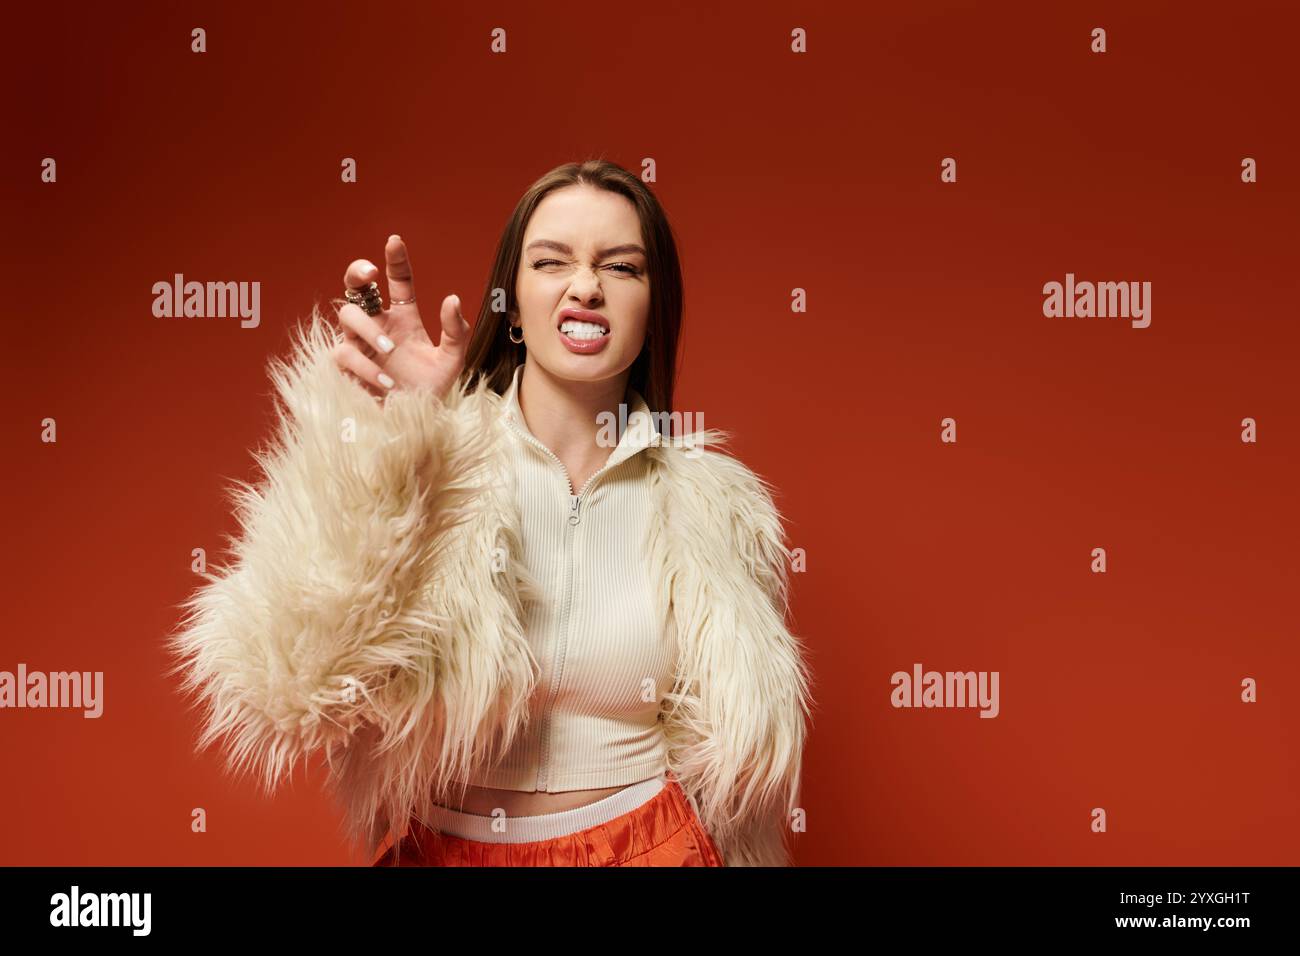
[468,365,677,792]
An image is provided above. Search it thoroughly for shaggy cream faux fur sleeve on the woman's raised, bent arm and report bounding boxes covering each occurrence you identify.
[166,307,506,792]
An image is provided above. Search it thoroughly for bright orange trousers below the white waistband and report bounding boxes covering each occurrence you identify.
[374,774,724,866]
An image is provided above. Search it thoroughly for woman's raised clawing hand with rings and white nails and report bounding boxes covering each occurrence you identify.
[334,235,469,398]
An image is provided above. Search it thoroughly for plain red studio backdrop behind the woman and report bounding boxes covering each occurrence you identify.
[0,0,1300,865]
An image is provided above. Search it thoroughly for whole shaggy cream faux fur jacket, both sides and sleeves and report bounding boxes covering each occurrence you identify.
[168,308,811,866]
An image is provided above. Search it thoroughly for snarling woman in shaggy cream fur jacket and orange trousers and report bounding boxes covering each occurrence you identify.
[163,161,810,866]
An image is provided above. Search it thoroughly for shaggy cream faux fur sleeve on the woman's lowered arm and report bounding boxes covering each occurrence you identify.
[657,429,813,866]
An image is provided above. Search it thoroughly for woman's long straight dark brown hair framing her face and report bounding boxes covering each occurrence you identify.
[462,159,683,423]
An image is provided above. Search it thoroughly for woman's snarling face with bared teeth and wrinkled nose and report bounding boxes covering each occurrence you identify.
[515,185,650,382]
